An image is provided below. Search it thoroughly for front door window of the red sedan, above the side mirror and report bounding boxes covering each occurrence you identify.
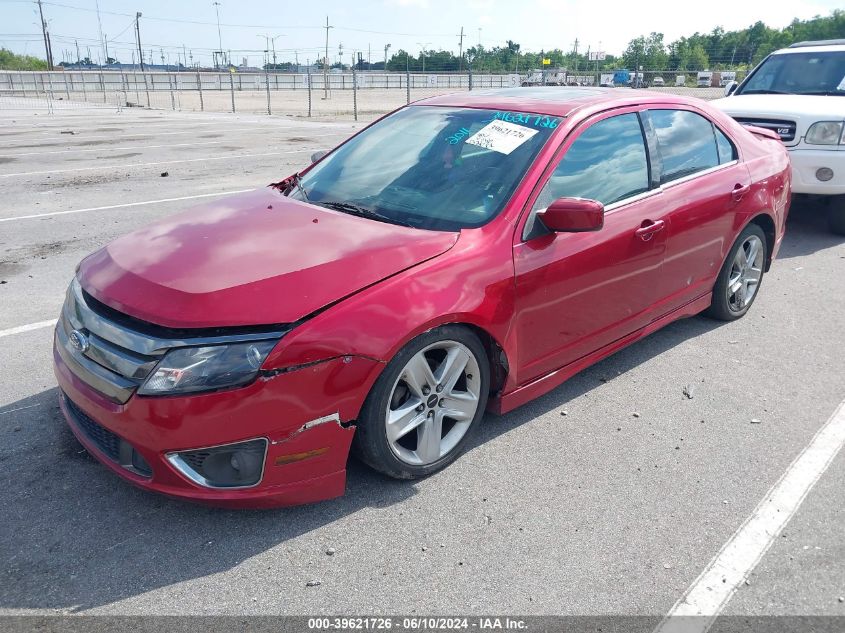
[534,113,648,210]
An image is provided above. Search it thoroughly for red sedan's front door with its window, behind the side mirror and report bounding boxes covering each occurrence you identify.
[514,110,668,384]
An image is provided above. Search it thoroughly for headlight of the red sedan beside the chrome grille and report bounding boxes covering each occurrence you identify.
[138,340,276,396]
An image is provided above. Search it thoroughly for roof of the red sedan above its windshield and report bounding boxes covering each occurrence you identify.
[414,86,692,117]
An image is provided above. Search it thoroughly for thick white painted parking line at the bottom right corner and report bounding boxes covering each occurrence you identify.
[655,401,845,633]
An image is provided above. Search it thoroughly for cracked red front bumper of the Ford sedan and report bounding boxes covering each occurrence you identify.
[54,340,382,508]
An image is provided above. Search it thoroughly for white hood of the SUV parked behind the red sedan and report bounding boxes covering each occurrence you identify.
[710,94,845,122]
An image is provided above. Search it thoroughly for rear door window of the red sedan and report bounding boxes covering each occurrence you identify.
[648,110,719,184]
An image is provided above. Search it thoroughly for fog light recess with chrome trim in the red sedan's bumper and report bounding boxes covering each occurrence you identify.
[167,438,267,488]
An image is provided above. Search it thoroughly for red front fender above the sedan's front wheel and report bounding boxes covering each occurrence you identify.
[264,229,514,388]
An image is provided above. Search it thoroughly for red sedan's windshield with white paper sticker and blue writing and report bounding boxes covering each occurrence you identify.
[288,106,560,231]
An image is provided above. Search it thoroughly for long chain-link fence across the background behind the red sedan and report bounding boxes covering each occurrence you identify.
[0,70,740,120]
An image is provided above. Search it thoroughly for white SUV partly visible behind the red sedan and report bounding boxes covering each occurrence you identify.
[712,40,845,235]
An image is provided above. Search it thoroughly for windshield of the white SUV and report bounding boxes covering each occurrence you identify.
[737,50,845,95]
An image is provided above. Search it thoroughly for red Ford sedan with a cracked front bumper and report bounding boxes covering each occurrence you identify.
[54,88,790,507]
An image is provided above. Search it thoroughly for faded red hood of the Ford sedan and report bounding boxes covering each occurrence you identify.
[78,188,459,328]
